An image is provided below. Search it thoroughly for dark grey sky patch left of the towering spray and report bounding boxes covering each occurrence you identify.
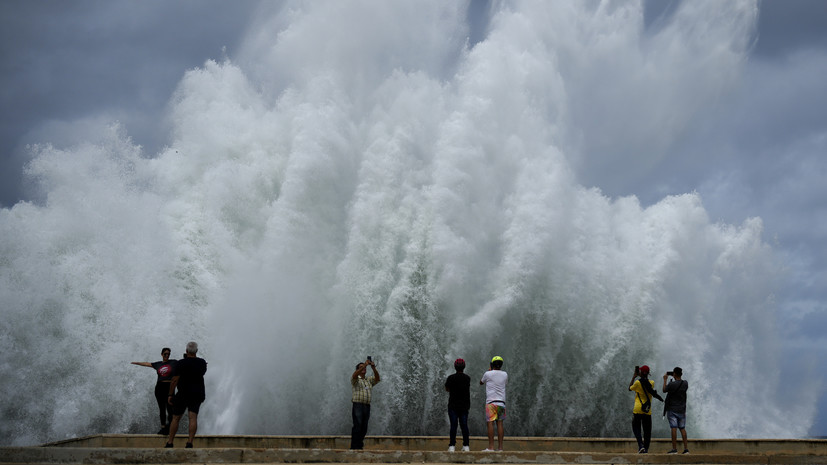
[0,0,258,206]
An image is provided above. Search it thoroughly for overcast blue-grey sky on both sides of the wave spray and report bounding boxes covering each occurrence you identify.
[0,0,827,435]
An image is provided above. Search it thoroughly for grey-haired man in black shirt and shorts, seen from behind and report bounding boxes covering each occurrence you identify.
[164,342,207,449]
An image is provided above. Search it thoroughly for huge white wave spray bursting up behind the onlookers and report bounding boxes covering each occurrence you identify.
[0,1,817,444]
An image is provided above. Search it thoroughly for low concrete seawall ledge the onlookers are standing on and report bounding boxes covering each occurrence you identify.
[0,434,827,465]
